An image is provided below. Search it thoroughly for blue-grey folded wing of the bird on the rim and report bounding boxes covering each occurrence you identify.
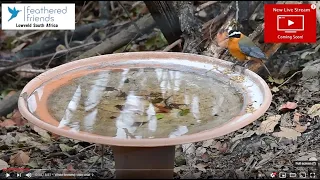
[239,36,266,59]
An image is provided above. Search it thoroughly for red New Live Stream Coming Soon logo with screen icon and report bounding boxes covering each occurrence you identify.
[264,4,317,43]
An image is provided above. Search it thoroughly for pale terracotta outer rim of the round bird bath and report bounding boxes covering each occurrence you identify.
[18,52,272,147]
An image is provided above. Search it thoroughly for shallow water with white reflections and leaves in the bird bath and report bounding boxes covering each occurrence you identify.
[28,68,243,139]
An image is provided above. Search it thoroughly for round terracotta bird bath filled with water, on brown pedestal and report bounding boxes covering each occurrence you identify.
[18,52,271,178]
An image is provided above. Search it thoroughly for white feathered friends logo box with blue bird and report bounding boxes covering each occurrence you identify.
[1,3,75,30]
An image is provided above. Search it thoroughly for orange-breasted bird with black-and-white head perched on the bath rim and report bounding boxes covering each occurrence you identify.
[227,30,271,75]
